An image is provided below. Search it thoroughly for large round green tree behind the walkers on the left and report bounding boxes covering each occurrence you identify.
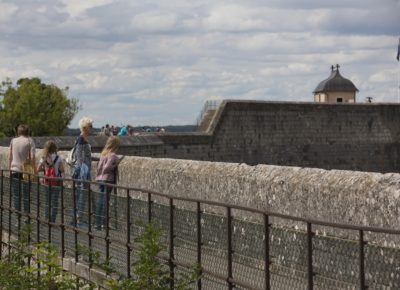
[0,78,79,136]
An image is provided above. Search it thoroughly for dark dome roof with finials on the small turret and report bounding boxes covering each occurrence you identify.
[313,66,358,94]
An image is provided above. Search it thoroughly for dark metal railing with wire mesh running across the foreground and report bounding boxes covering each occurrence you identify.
[0,170,400,289]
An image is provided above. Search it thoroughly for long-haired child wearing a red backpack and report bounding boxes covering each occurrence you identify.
[38,140,64,223]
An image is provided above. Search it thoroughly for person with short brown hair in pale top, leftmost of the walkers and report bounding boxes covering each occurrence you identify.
[9,124,35,212]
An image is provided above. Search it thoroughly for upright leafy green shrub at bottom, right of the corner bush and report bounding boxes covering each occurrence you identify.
[108,224,200,290]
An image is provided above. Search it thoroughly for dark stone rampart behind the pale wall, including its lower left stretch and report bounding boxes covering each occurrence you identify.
[0,100,400,173]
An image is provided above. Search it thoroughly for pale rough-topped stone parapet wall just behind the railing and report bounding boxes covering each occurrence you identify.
[0,147,400,234]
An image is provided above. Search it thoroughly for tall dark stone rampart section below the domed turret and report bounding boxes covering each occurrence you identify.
[208,101,400,172]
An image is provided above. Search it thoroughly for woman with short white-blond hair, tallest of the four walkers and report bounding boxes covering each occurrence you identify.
[72,117,93,225]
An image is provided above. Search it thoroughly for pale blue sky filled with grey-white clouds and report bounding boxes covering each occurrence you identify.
[0,0,400,127]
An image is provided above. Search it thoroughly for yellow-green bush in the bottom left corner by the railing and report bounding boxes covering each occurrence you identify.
[0,225,93,290]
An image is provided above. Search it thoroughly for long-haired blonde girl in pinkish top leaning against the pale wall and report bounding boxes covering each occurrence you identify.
[96,136,121,230]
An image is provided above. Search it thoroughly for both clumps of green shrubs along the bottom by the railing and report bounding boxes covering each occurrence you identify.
[0,224,201,290]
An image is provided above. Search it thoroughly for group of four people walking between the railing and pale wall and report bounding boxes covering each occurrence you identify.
[9,117,122,230]
